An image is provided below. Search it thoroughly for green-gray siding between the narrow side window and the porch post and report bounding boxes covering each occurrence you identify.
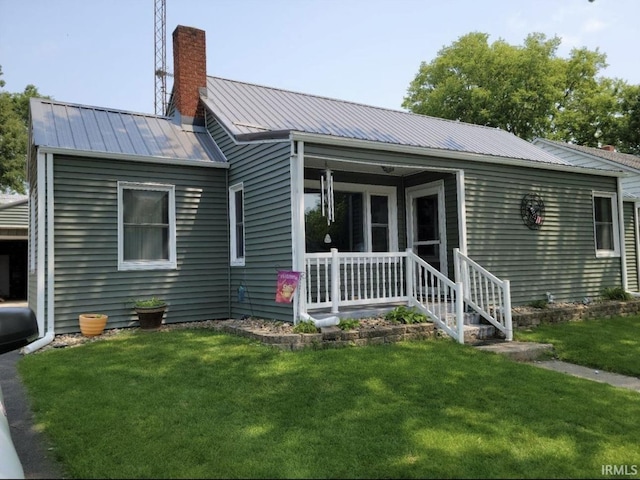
[207,118,293,321]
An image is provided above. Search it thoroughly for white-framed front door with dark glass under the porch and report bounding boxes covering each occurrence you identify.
[407,182,447,275]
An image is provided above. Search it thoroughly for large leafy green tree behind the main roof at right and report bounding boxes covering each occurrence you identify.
[402,32,640,151]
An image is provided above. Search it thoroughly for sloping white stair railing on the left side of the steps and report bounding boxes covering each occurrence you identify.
[407,249,464,343]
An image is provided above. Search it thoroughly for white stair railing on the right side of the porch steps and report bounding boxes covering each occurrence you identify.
[453,248,513,341]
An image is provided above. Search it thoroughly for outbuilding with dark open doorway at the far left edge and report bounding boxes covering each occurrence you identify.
[0,194,29,301]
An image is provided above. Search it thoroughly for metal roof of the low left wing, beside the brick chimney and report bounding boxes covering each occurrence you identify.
[30,98,226,162]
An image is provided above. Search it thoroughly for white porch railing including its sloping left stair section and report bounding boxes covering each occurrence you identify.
[305,249,464,343]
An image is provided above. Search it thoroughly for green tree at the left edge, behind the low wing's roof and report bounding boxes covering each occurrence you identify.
[0,66,47,193]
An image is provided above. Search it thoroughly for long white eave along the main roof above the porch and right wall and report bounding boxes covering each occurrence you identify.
[291,131,627,177]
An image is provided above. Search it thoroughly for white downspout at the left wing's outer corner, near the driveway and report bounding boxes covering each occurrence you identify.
[22,152,55,354]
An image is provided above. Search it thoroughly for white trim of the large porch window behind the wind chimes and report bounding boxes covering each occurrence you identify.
[303,180,398,252]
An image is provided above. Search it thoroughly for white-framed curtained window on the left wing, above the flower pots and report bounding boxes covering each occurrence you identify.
[118,182,177,270]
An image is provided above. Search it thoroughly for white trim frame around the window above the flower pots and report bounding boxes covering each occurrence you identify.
[118,182,178,271]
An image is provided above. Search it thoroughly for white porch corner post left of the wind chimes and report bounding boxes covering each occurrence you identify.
[291,140,307,324]
